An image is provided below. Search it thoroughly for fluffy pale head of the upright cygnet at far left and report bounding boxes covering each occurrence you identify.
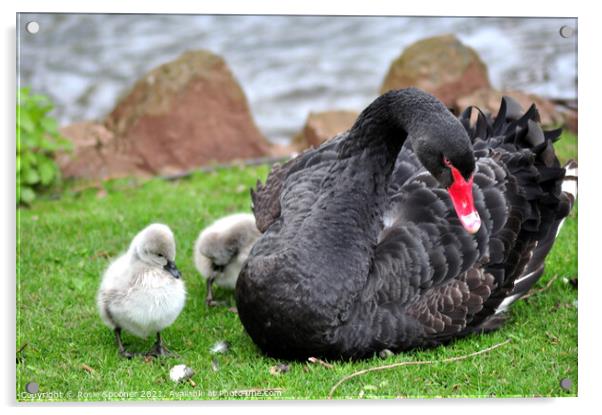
[130,223,181,278]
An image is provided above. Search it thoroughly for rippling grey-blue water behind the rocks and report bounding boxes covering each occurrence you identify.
[18,14,577,143]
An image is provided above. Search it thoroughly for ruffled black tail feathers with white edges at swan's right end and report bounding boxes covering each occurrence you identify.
[460,97,577,324]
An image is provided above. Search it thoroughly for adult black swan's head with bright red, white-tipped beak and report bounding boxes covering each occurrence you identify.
[412,122,481,234]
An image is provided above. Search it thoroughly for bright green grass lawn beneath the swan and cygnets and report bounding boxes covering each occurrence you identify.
[16,136,577,401]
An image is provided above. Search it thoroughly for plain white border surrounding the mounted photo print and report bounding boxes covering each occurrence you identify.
[0,0,602,415]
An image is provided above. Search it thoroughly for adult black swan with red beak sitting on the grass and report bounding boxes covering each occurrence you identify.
[236,88,574,359]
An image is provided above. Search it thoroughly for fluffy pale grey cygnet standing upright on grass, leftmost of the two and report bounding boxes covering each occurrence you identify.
[97,223,186,358]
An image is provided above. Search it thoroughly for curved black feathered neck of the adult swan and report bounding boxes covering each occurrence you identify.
[298,89,458,288]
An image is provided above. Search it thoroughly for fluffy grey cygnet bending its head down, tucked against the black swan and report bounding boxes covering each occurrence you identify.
[194,213,261,306]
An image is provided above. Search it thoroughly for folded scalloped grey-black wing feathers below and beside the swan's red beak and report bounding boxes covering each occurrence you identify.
[366,145,527,342]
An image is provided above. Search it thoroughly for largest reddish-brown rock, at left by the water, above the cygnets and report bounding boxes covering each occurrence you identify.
[61,51,270,178]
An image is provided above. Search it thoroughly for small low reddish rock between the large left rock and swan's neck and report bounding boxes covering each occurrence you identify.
[293,110,359,150]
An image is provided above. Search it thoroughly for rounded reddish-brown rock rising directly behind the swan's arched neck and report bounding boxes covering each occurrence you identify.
[381,35,491,107]
